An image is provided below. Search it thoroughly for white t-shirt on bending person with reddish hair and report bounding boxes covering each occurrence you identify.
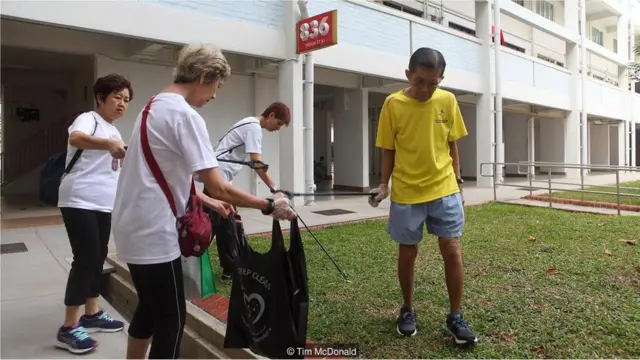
[214,116,262,182]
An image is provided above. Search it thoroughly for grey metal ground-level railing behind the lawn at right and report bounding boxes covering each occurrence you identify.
[480,161,640,215]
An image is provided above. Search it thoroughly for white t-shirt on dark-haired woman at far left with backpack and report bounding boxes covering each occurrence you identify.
[58,111,122,212]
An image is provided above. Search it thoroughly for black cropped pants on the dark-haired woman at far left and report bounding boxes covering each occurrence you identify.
[60,208,111,306]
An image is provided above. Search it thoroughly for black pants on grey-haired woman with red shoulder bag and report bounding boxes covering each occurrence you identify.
[127,258,187,359]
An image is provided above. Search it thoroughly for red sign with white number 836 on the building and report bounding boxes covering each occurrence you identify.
[296,10,338,54]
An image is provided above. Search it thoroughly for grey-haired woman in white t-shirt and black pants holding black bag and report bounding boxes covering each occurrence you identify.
[113,44,295,359]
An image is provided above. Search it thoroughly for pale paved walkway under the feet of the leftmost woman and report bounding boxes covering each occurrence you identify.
[0,226,128,359]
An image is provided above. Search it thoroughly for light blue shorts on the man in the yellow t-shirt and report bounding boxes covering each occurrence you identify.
[387,193,464,245]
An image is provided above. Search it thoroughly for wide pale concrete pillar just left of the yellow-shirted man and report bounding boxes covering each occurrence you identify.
[332,88,375,191]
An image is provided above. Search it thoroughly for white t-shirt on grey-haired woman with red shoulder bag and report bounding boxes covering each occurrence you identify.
[112,93,218,265]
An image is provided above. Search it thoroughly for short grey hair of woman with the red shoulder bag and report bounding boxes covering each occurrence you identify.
[173,43,231,84]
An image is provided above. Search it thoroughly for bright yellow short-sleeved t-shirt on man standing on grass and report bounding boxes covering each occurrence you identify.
[376,89,467,204]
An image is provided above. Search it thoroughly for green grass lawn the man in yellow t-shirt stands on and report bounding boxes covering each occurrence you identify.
[212,203,640,358]
